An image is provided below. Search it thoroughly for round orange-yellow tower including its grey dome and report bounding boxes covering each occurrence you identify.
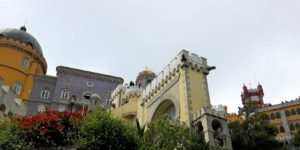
[0,26,47,101]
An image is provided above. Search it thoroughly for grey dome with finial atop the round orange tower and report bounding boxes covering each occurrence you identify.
[0,26,43,54]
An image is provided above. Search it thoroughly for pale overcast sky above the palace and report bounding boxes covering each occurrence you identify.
[0,0,300,112]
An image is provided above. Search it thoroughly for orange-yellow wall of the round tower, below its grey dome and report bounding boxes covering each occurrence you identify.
[0,38,47,100]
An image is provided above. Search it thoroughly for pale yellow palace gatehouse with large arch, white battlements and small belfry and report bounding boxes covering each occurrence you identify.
[111,50,232,149]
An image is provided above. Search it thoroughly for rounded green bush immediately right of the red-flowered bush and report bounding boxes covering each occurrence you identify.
[77,110,139,150]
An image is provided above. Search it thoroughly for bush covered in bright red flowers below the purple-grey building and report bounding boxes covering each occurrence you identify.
[14,111,82,148]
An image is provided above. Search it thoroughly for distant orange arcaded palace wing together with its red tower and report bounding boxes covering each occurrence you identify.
[226,84,300,142]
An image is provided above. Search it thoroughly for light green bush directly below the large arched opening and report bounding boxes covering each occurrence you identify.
[140,117,209,150]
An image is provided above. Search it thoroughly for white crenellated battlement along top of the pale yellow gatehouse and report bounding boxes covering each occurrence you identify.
[142,50,208,99]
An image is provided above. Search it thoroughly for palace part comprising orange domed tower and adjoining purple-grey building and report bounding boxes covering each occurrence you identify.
[0,27,123,115]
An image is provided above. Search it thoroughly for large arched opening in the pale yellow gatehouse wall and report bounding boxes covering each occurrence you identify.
[151,100,176,121]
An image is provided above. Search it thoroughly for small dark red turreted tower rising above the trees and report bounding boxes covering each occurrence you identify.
[241,84,264,108]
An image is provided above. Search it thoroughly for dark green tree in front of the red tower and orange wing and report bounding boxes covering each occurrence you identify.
[229,105,285,150]
